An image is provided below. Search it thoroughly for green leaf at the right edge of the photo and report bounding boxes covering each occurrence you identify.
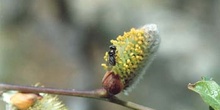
[188,78,220,110]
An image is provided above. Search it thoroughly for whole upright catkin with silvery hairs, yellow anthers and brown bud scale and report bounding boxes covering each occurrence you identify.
[102,24,160,95]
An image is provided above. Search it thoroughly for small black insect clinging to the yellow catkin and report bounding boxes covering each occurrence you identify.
[108,45,116,66]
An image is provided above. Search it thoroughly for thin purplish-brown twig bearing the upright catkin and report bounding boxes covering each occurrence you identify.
[0,84,154,110]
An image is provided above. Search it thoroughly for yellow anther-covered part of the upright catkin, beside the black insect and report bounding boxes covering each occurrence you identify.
[102,28,147,86]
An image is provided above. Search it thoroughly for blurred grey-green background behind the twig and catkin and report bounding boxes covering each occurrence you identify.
[0,0,220,110]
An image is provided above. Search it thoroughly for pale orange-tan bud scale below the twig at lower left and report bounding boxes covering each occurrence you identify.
[10,93,42,110]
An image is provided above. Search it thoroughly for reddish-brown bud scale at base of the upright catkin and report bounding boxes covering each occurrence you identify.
[102,71,124,95]
